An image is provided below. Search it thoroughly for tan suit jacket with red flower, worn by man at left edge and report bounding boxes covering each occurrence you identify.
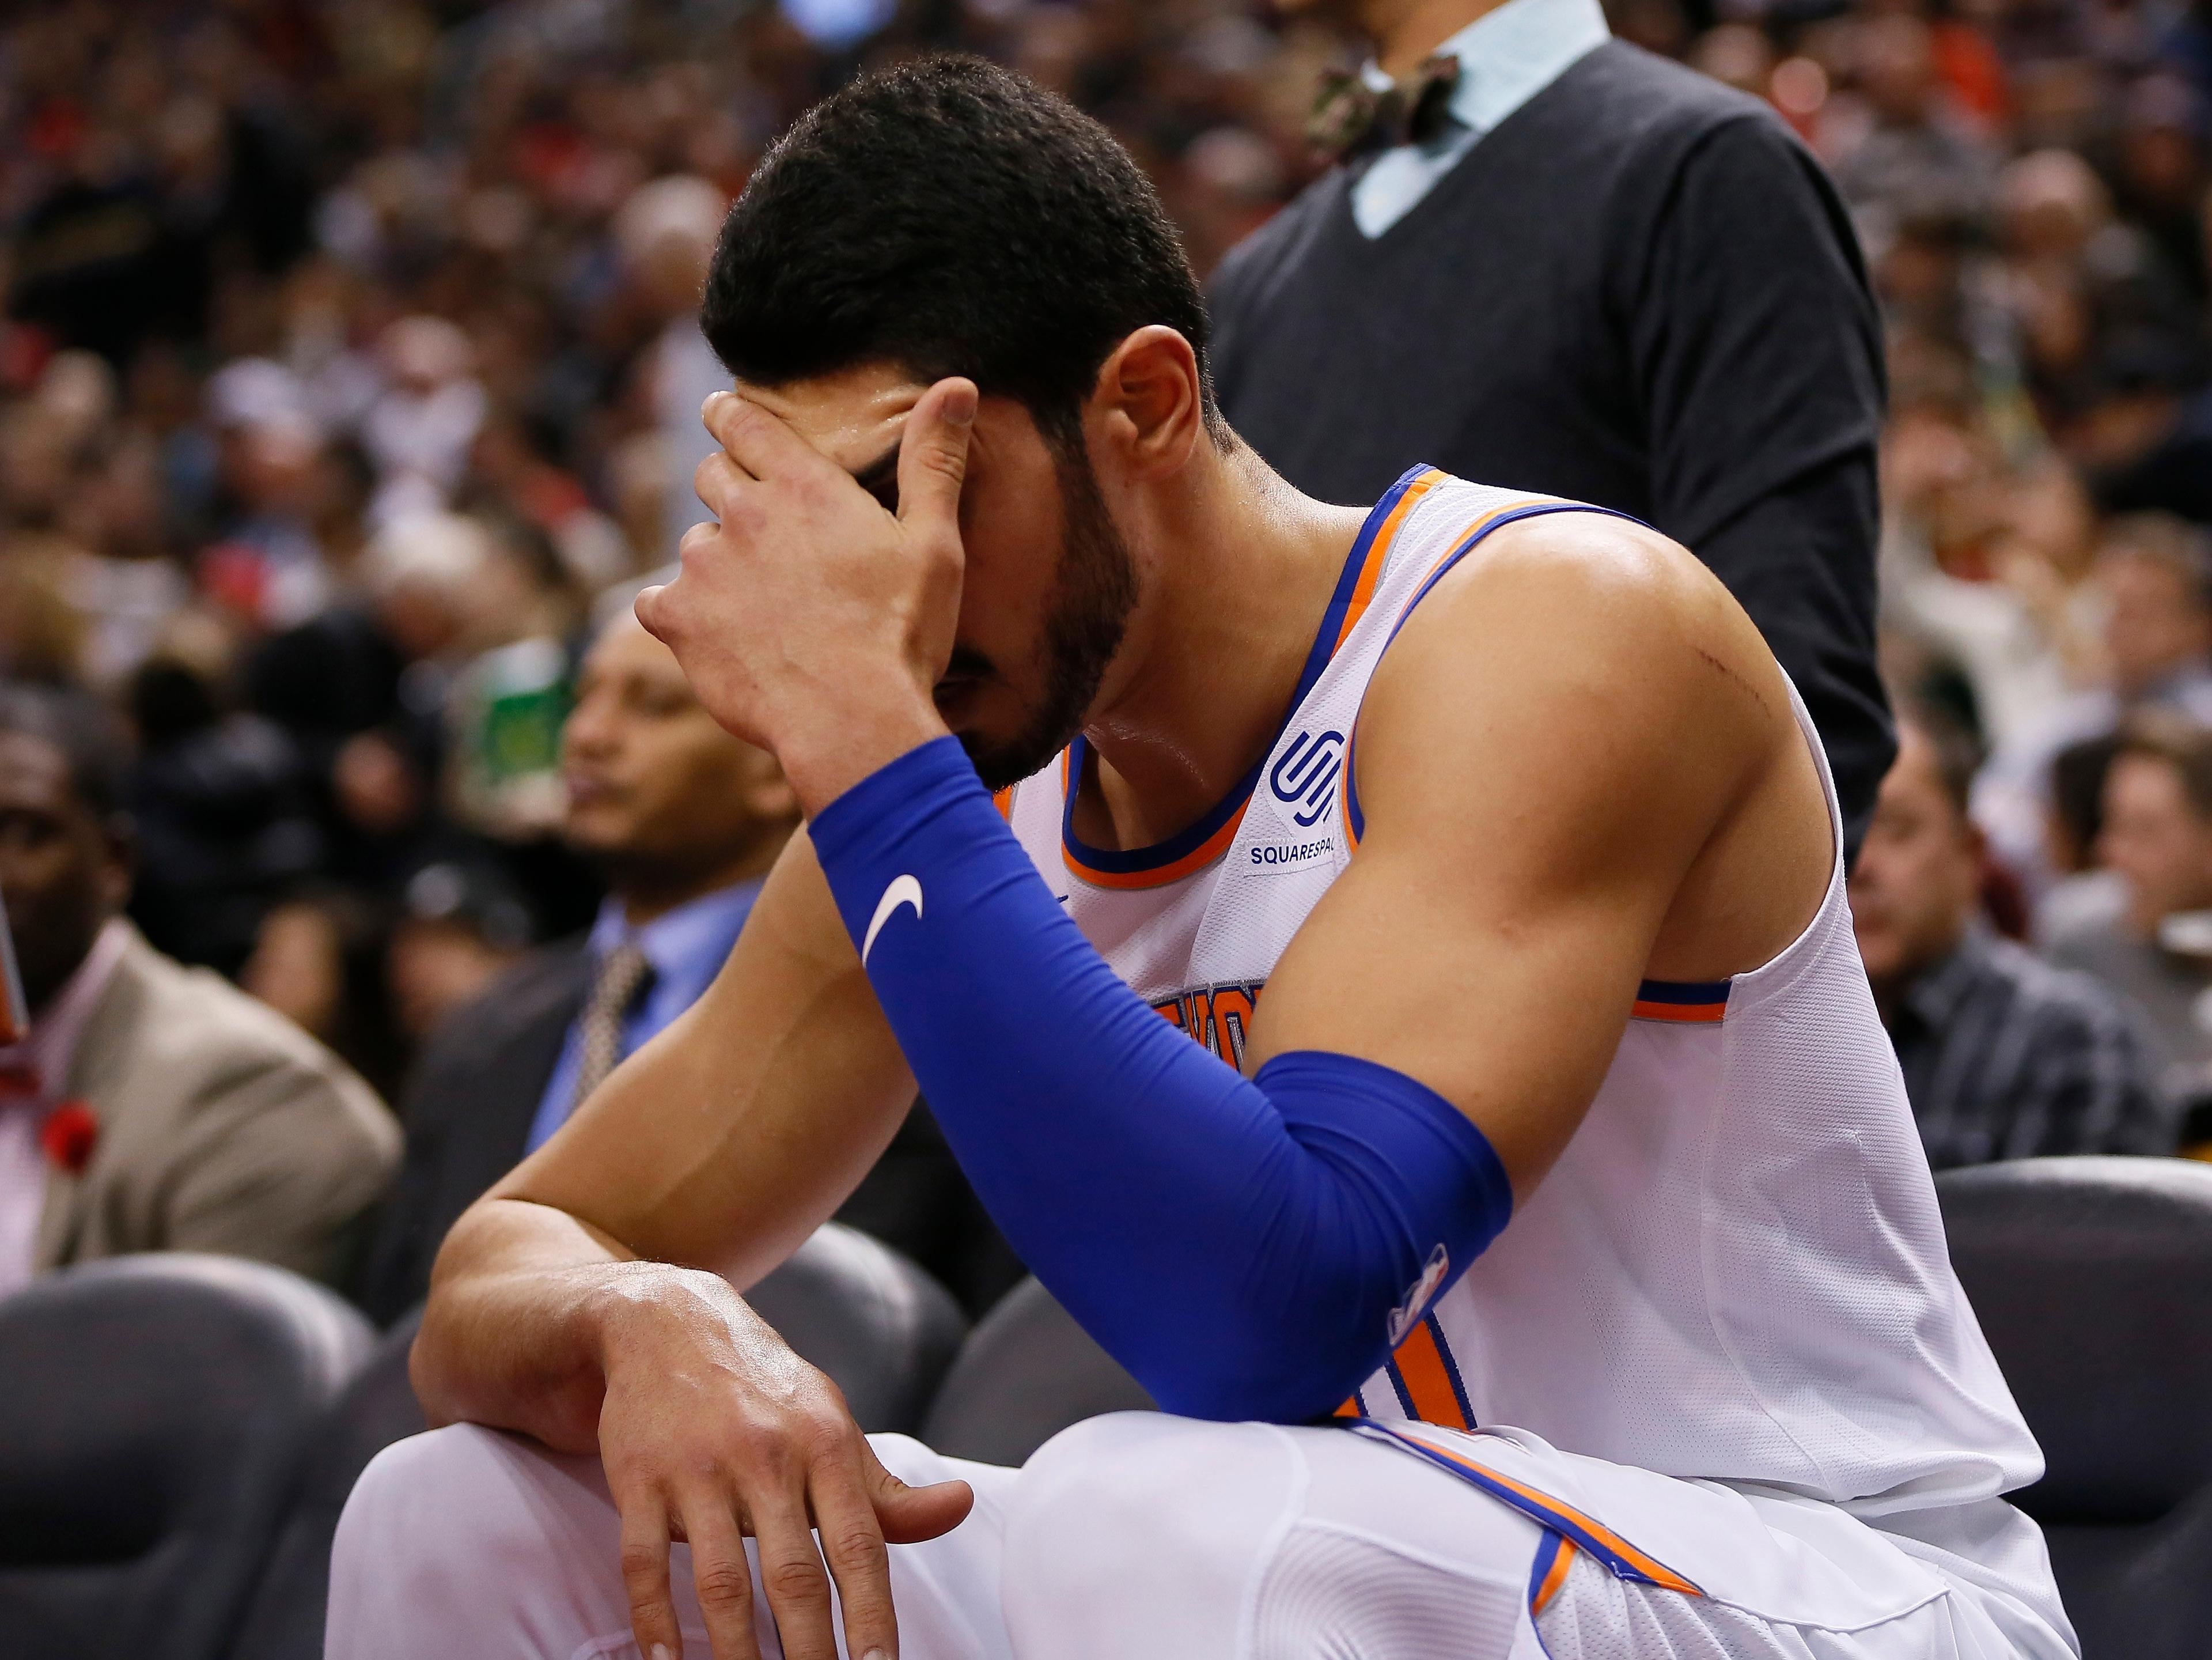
[33,929,400,1279]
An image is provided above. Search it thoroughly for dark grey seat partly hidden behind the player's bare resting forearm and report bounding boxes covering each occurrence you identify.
[230,1222,967,1660]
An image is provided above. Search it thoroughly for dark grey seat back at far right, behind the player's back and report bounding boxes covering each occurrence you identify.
[1936,1158,2212,1660]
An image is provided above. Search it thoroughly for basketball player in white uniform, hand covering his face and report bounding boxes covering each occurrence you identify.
[329,60,2075,1660]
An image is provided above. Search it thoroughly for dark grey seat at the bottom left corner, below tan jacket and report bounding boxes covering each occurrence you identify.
[0,1255,374,1660]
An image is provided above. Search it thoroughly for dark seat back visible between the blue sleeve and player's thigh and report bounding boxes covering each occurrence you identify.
[922,1279,1153,1465]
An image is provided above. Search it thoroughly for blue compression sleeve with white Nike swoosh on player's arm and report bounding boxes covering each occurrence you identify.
[812,737,1513,1423]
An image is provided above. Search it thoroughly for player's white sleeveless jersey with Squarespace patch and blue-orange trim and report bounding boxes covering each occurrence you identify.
[1000,469,2048,1620]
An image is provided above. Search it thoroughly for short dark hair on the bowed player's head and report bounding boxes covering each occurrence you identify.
[699,55,1219,443]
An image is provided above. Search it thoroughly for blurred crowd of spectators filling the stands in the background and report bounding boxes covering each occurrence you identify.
[0,0,2212,1310]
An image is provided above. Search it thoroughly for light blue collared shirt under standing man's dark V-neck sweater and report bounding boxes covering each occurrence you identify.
[1351,0,1611,239]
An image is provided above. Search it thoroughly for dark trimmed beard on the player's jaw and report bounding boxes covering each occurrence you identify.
[960,434,1137,790]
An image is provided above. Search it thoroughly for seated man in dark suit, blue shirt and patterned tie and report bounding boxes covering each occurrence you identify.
[356,593,1020,1324]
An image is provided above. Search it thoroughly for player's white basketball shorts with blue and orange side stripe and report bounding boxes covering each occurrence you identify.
[325,1412,2075,1660]
